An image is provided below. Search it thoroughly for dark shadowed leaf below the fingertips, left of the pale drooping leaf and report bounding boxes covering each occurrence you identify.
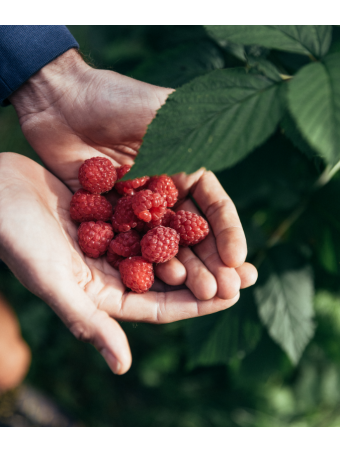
[186,290,262,368]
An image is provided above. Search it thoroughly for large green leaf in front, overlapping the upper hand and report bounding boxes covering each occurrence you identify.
[130,68,284,177]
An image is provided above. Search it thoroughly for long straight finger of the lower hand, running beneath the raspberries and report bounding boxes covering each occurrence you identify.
[101,290,240,323]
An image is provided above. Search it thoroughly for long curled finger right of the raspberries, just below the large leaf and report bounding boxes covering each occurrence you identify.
[174,170,247,268]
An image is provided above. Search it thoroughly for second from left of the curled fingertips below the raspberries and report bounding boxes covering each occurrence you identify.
[177,246,217,300]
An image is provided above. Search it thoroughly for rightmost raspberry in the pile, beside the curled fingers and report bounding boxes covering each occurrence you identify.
[170,210,209,246]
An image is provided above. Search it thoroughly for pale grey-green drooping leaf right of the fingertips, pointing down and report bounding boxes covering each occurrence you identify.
[254,245,314,364]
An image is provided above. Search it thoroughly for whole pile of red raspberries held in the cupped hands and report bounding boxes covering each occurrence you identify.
[70,157,209,293]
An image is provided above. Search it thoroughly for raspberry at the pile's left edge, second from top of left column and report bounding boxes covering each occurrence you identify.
[70,188,112,223]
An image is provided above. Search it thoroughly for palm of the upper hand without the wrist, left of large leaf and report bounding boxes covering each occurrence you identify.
[15,69,172,191]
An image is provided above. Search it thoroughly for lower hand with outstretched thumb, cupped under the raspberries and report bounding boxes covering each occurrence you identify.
[0,153,255,374]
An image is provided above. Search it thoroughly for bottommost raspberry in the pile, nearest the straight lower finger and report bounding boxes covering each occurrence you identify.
[119,256,155,293]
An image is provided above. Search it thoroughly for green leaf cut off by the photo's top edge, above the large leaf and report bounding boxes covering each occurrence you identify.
[205,25,332,58]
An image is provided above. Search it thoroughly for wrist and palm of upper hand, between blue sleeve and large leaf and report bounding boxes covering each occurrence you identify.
[10,49,173,191]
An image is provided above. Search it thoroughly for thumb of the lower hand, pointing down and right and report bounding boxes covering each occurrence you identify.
[51,283,132,375]
